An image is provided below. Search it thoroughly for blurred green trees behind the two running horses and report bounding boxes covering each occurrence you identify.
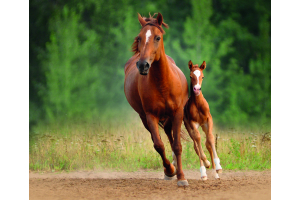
[29,0,271,130]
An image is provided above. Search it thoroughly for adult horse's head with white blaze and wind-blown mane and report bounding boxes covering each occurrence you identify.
[132,13,168,75]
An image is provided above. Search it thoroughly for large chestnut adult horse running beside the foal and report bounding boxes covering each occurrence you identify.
[124,13,188,186]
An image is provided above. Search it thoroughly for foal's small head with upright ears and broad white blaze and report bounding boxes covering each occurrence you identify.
[189,60,206,96]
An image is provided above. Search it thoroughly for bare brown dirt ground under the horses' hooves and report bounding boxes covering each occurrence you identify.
[29,169,271,200]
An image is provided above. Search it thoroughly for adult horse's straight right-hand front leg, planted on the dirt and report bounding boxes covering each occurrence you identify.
[172,108,189,186]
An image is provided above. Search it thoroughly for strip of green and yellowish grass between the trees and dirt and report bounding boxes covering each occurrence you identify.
[29,112,271,171]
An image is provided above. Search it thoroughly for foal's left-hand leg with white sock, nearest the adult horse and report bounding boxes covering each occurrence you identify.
[184,115,210,180]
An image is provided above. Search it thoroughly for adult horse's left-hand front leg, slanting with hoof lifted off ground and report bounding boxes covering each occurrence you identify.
[146,114,176,180]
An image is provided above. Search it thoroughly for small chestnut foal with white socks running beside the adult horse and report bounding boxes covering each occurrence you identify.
[183,61,222,180]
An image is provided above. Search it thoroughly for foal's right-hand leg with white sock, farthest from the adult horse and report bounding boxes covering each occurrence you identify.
[201,119,222,178]
